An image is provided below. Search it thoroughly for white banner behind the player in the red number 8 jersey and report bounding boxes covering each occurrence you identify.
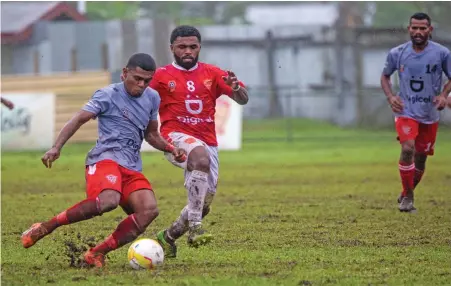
[141,96,243,151]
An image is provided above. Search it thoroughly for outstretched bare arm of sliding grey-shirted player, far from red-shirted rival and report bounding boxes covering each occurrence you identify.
[41,110,94,168]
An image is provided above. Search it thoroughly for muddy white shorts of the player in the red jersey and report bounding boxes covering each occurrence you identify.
[164,132,219,193]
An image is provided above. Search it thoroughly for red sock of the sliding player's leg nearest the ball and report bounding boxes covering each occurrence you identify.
[92,214,143,254]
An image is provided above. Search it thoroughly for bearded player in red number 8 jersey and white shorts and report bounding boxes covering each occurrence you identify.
[150,26,249,257]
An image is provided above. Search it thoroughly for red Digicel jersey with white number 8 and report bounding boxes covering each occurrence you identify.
[149,63,243,146]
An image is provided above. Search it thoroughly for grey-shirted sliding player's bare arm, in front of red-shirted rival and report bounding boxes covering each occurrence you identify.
[144,120,186,162]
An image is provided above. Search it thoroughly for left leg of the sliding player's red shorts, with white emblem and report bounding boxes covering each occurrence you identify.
[85,160,122,201]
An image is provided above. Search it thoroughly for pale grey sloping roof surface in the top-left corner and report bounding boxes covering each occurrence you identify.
[1,1,60,33]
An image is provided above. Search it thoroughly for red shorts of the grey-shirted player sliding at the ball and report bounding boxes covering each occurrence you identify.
[85,160,152,206]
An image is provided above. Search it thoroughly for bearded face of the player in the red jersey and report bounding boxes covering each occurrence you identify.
[171,36,200,70]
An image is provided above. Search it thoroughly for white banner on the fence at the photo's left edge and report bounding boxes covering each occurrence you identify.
[1,93,55,150]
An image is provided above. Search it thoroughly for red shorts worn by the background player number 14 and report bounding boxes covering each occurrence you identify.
[395,117,438,156]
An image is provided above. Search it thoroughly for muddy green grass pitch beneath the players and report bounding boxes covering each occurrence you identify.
[1,121,451,286]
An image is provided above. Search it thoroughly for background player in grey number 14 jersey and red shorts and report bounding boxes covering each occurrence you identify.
[381,13,451,212]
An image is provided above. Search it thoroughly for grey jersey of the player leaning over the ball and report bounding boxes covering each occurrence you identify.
[83,83,160,171]
